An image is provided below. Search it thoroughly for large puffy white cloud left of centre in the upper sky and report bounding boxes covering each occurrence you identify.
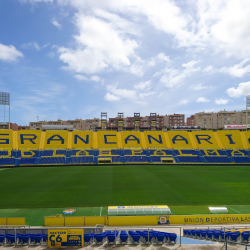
[58,13,138,74]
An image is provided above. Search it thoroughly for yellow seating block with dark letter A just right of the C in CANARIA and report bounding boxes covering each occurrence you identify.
[121,131,143,148]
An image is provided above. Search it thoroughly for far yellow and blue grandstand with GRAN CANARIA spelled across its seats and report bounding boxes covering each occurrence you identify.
[0,130,250,166]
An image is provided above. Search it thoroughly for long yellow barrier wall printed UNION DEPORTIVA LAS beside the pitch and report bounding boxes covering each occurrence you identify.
[44,214,250,226]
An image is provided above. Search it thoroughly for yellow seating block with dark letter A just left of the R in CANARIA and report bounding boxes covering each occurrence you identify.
[167,131,193,149]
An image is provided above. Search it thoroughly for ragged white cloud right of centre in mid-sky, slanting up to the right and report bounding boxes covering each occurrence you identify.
[160,60,200,88]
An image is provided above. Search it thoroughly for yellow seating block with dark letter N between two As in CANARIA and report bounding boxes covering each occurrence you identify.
[143,131,168,148]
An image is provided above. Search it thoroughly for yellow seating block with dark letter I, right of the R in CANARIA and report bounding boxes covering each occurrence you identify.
[217,130,244,149]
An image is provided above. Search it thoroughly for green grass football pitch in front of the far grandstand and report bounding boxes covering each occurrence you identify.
[0,165,250,225]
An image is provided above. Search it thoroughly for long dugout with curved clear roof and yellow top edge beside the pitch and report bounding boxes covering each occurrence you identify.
[108,205,171,216]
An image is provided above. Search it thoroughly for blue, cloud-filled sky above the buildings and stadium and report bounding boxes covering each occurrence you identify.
[0,0,250,125]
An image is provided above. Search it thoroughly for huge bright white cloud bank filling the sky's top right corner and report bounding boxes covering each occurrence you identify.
[22,0,250,58]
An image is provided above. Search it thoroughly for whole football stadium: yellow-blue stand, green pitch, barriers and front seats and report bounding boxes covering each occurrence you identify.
[0,130,250,246]
